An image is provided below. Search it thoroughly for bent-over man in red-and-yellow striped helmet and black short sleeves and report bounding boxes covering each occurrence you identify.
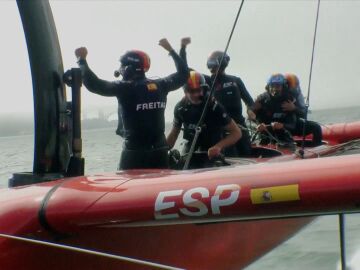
[167,71,241,168]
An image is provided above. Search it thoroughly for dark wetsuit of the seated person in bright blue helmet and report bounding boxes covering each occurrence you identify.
[254,92,298,144]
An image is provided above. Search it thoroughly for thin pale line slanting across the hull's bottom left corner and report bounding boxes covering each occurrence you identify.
[0,233,182,270]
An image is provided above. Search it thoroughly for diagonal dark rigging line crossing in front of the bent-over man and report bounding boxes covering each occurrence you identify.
[183,0,245,170]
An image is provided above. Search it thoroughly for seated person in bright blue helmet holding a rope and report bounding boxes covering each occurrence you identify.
[253,74,297,144]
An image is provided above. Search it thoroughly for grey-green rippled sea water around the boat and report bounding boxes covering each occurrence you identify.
[0,108,360,270]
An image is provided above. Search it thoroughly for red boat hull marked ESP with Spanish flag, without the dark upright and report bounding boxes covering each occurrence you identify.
[0,123,360,270]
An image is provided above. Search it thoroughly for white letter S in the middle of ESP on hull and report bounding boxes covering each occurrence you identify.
[180,187,209,217]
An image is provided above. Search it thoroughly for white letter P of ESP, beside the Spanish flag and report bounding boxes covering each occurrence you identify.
[211,184,240,215]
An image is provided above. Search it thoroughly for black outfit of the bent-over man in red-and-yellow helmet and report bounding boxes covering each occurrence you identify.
[173,98,231,168]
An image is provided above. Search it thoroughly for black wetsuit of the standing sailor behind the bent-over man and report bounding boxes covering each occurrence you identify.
[180,47,254,157]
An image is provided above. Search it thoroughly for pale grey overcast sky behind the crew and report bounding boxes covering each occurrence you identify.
[0,0,360,121]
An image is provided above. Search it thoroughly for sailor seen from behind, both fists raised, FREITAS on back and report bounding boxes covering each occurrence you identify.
[75,39,188,169]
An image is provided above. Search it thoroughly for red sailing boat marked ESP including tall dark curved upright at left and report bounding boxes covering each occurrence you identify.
[0,1,360,269]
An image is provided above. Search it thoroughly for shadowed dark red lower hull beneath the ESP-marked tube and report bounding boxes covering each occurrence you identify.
[0,218,312,270]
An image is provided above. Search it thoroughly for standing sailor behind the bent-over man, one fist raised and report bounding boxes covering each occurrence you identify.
[180,37,255,157]
